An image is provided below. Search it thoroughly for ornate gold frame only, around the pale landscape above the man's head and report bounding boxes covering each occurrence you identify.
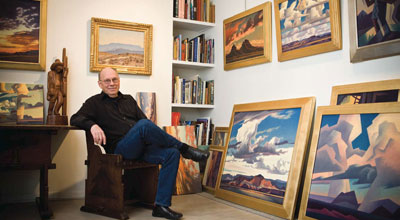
[90,18,153,75]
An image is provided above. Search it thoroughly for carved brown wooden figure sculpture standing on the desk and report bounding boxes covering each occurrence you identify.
[47,48,68,125]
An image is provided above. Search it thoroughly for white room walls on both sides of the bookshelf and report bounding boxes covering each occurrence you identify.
[0,0,400,203]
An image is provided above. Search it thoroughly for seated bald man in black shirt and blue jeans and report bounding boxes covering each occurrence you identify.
[71,67,209,219]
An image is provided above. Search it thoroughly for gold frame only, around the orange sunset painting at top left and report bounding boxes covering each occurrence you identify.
[0,0,47,70]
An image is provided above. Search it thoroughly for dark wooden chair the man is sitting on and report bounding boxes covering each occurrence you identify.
[81,132,159,219]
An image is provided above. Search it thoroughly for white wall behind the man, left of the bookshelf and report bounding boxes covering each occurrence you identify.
[0,0,173,203]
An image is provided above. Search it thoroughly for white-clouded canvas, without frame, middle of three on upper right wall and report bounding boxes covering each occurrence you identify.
[279,0,331,52]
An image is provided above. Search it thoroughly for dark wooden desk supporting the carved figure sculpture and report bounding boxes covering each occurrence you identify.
[0,125,79,218]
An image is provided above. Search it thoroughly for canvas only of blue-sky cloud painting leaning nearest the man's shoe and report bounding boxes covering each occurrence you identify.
[220,108,301,204]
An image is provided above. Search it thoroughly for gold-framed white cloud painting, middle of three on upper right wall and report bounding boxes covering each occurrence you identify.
[274,0,342,62]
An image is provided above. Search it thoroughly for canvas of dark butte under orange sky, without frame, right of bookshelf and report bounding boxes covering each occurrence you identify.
[224,10,265,64]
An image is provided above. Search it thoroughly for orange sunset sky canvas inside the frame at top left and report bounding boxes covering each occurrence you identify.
[0,0,40,63]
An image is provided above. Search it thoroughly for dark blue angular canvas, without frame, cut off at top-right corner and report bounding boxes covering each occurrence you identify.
[356,0,400,47]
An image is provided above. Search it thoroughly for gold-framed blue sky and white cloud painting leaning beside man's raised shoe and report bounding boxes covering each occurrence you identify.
[216,97,315,219]
